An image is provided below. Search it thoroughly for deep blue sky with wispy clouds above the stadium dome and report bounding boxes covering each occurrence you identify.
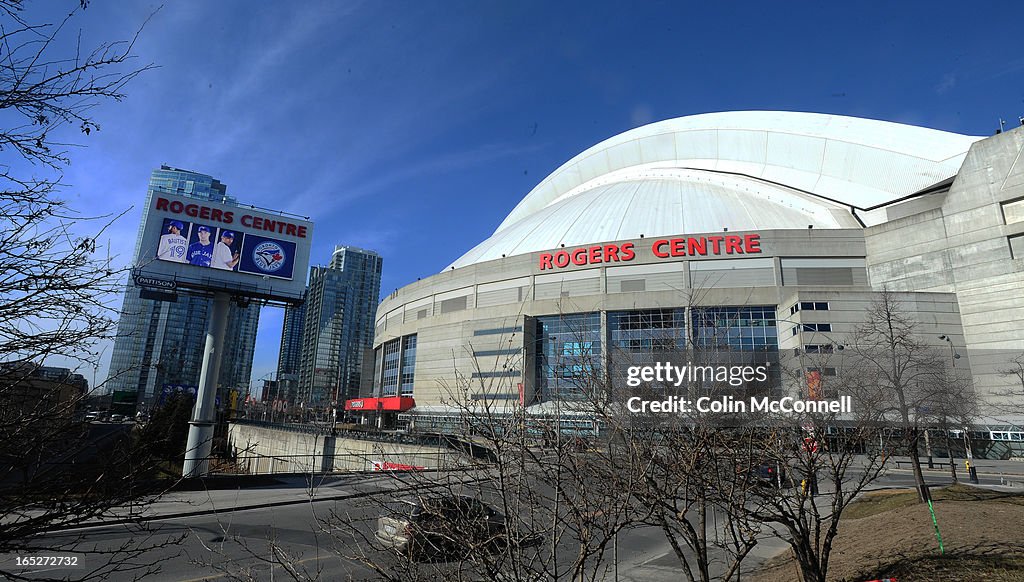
[26,0,1024,393]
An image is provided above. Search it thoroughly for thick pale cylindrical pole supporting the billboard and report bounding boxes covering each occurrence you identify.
[181,292,230,477]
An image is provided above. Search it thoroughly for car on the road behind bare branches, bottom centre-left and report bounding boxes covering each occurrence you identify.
[375,495,508,559]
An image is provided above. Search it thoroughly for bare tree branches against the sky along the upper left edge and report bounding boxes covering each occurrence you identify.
[0,0,153,370]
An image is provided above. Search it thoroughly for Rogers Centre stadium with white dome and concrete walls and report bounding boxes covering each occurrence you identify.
[345,112,1024,452]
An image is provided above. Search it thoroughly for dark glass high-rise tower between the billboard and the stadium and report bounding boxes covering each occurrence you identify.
[294,246,383,408]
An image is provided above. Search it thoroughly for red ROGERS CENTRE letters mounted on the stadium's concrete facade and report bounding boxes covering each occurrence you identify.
[540,234,761,271]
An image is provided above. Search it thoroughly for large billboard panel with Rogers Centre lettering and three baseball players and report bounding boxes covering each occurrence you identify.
[133,193,312,301]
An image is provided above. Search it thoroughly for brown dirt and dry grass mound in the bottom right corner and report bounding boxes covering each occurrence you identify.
[748,487,1024,582]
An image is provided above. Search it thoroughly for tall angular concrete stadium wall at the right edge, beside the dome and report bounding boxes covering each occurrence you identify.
[865,128,1024,422]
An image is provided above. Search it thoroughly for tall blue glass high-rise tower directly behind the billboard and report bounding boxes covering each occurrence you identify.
[108,166,259,408]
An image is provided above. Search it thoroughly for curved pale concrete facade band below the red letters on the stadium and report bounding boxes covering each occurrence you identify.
[372,228,868,412]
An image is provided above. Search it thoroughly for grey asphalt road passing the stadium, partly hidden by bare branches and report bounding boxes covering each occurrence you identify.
[9,461,1024,582]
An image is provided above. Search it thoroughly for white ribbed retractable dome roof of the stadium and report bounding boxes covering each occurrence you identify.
[450,112,981,268]
